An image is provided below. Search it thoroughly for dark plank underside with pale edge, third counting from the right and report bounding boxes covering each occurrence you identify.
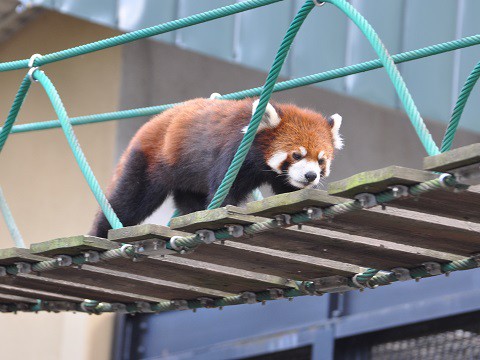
[234,225,464,270]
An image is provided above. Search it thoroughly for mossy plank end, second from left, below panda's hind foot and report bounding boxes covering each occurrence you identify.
[30,235,119,256]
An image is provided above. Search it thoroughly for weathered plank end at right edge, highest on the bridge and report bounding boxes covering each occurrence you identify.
[423,144,480,172]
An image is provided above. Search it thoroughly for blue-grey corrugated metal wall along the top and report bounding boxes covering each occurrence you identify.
[26,0,480,131]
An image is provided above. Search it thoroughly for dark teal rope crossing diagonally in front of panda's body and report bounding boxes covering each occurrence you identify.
[208,0,315,209]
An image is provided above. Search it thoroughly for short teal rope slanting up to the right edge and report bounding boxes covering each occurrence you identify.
[441,62,480,152]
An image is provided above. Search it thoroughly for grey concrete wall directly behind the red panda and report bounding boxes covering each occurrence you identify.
[116,41,480,223]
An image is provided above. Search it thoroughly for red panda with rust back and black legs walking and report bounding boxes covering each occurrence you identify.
[90,98,343,237]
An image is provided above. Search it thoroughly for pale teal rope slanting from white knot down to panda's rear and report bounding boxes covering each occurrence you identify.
[34,70,123,229]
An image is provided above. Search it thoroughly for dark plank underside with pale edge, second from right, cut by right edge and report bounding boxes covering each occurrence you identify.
[309,207,480,256]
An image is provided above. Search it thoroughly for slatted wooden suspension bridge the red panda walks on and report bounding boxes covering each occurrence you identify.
[0,144,480,313]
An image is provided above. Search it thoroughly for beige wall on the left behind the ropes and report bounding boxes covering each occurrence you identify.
[0,12,121,360]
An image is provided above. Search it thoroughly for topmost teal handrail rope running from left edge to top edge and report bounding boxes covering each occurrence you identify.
[0,0,283,72]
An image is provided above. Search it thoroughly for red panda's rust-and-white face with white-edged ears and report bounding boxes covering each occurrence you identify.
[252,100,343,189]
